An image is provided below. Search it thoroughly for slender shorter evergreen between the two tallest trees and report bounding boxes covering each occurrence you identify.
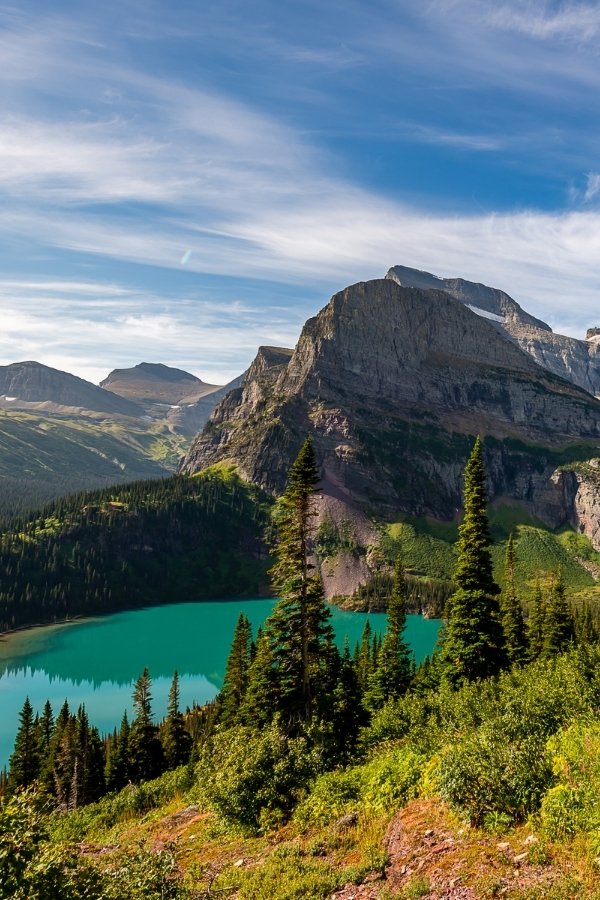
[364,553,413,711]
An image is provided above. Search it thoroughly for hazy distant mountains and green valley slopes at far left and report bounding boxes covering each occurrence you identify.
[0,361,244,513]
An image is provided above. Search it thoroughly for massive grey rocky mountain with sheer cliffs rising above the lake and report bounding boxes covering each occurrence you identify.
[182,277,600,596]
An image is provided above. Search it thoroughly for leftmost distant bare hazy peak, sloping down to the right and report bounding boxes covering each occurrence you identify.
[0,361,144,418]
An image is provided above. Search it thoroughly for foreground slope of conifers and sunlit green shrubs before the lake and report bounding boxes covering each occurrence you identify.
[0,440,600,900]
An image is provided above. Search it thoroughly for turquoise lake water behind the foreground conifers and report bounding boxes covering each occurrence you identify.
[0,600,440,768]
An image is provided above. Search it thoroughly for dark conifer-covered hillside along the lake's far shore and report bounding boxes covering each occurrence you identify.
[0,469,269,631]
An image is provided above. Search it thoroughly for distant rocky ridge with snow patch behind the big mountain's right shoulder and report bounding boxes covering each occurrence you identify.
[386,266,600,397]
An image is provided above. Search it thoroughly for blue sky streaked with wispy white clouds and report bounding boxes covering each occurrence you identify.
[0,0,600,383]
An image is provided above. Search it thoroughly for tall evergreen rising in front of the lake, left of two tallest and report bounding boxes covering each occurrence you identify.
[266,437,334,727]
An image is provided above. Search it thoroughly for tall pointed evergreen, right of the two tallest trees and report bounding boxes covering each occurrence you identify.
[441,438,506,685]
